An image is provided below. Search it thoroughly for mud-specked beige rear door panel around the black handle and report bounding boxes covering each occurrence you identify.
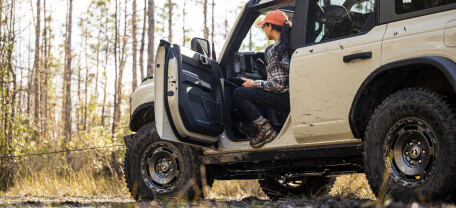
[290,25,386,143]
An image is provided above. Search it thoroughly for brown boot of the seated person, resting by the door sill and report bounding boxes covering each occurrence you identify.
[250,118,277,148]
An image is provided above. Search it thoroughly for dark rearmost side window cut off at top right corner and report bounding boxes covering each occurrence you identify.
[395,0,456,14]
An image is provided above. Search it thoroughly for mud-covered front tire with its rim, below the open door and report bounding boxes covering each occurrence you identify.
[124,122,201,200]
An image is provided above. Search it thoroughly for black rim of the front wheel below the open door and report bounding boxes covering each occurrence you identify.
[140,144,182,193]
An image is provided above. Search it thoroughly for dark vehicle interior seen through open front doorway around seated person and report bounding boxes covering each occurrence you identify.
[225,3,295,141]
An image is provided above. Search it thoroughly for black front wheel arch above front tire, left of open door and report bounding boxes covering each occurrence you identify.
[129,101,155,132]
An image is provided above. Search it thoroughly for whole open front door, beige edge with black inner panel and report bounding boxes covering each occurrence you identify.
[155,40,224,145]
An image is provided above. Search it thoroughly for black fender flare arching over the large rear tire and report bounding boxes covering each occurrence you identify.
[349,56,456,138]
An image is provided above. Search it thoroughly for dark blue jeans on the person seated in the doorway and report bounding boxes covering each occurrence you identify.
[233,87,290,121]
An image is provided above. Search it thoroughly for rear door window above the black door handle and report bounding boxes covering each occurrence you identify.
[306,0,375,44]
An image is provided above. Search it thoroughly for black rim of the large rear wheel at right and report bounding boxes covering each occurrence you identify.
[383,117,438,188]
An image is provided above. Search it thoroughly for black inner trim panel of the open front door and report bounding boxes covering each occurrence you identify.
[174,45,224,136]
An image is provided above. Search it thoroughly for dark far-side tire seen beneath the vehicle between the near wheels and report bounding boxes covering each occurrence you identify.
[258,176,335,200]
